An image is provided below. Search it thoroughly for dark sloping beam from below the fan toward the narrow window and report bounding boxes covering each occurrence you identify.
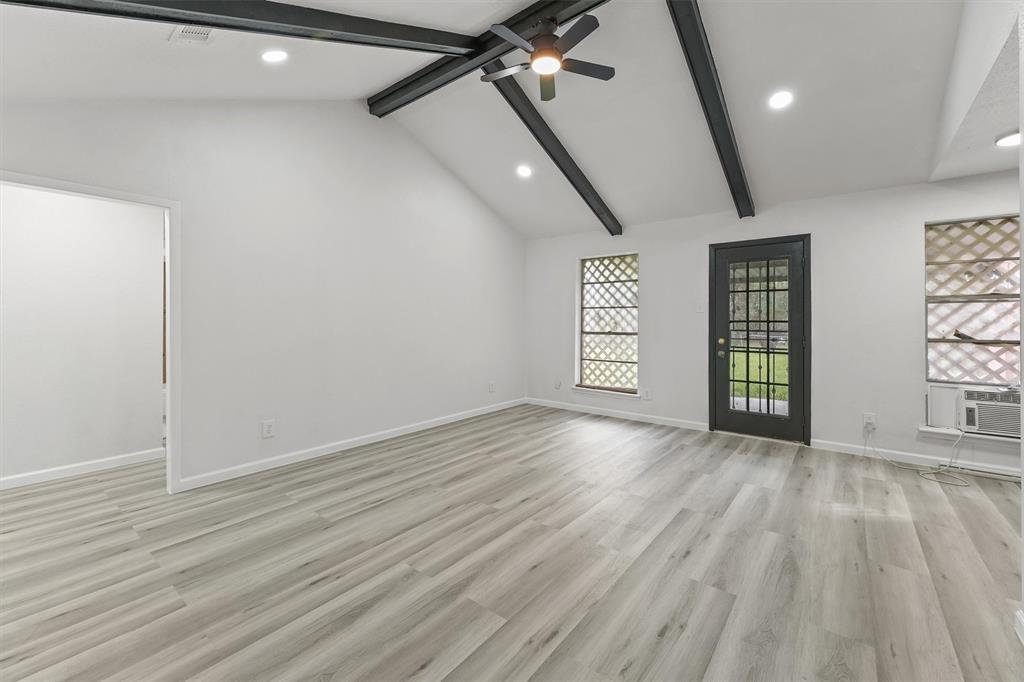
[483,59,623,237]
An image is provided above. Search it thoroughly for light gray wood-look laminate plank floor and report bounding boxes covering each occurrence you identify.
[0,407,1024,682]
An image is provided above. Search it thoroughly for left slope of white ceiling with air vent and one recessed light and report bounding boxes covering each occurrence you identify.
[0,5,433,99]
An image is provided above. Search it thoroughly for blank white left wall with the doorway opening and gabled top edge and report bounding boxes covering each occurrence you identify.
[0,101,524,486]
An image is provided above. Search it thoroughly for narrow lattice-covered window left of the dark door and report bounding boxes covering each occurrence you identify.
[578,253,640,393]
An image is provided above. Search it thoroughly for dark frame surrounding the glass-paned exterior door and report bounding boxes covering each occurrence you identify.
[708,233,813,445]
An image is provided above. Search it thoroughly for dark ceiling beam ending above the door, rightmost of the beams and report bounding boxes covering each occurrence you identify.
[667,0,754,218]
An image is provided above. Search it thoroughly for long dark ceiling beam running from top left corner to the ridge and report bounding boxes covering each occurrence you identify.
[0,0,479,54]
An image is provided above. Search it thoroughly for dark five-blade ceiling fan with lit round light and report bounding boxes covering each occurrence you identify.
[480,14,615,101]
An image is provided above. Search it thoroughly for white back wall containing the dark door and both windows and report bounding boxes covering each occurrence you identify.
[526,173,1020,471]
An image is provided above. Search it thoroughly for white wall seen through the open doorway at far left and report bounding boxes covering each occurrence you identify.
[0,184,164,484]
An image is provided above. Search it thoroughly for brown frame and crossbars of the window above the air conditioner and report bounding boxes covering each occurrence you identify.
[923,213,1024,387]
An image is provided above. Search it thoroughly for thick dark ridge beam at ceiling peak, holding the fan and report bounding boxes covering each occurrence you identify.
[367,0,608,117]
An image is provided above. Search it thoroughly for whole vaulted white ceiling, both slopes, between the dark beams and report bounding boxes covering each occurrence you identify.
[0,0,1016,236]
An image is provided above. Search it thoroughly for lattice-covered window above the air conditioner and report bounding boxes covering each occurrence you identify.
[925,216,1021,385]
